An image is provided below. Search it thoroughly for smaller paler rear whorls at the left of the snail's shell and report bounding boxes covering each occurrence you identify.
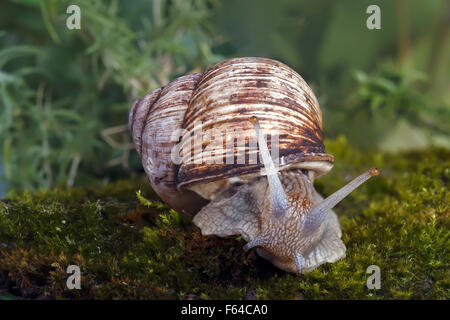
[129,73,206,215]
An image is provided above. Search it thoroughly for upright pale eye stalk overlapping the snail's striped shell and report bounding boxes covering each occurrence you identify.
[250,116,288,217]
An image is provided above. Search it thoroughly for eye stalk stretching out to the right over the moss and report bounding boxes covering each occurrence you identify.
[304,168,380,232]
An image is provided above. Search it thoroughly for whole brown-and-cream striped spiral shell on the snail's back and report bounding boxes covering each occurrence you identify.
[129,58,334,214]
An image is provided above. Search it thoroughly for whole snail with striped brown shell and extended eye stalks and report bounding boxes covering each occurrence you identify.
[129,57,378,274]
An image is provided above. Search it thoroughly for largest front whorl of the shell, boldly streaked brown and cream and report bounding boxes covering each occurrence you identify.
[178,58,334,198]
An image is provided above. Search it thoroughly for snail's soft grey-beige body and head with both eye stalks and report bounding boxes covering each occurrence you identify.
[193,116,379,274]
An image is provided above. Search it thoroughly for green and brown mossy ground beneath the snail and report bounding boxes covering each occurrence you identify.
[0,138,450,299]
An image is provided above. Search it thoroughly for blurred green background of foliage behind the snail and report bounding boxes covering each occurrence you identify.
[0,0,450,196]
